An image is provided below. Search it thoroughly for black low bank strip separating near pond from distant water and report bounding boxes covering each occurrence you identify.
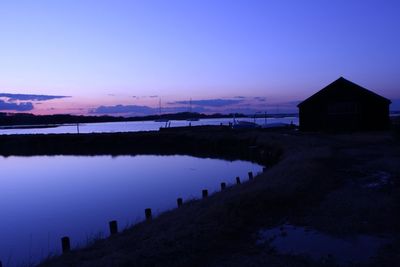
[0,126,282,165]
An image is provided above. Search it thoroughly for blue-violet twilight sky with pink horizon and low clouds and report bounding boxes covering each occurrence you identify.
[0,0,400,115]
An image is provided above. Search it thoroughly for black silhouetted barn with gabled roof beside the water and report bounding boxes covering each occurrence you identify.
[297,77,391,131]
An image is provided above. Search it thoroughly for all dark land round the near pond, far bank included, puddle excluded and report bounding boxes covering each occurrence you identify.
[0,128,400,266]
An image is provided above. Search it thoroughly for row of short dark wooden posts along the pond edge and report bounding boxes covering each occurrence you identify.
[60,170,266,255]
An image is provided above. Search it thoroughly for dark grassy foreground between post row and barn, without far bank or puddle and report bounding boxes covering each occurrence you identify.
[35,132,400,267]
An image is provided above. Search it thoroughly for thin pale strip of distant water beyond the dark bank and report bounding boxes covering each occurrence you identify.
[0,117,299,134]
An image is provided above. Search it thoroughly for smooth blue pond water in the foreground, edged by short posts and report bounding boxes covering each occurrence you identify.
[0,156,262,266]
